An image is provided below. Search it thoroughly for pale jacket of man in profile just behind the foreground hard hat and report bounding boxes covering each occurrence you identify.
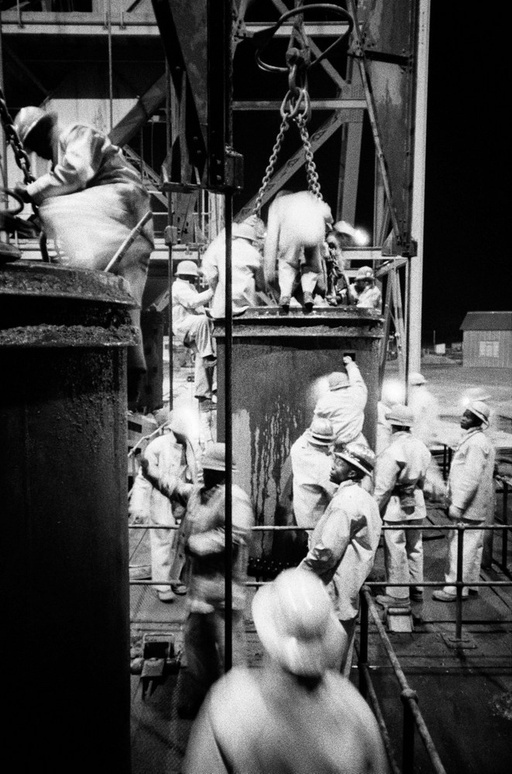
[300,480,382,621]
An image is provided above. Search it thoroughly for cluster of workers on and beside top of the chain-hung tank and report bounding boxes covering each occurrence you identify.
[172,200,382,401]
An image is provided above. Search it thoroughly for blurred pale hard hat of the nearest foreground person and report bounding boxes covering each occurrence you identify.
[252,567,347,677]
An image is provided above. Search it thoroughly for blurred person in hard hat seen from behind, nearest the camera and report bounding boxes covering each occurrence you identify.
[182,568,388,774]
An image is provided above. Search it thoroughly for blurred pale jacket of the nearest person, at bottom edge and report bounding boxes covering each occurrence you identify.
[182,663,388,774]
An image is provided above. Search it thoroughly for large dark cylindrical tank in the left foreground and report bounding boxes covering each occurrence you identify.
[0,261,134,774]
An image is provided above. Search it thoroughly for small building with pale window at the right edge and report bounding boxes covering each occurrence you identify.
[460,312,512,368]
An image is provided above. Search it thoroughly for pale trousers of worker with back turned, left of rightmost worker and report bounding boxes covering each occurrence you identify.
[383,519,423,600]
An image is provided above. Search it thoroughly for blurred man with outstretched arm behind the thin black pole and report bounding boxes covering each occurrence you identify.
[141,443,254,718]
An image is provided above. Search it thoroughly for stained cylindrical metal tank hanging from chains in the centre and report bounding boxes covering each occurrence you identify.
[214,307,383,561]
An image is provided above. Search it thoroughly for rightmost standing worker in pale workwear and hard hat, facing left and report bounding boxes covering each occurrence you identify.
[432,400,496,602]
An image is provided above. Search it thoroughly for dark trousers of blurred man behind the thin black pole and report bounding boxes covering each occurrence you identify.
[184,610,247,707]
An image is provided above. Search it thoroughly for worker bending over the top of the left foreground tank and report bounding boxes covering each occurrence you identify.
[14,106,154,410]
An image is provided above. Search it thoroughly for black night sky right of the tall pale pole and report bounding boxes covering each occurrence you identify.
[423,0,512,341]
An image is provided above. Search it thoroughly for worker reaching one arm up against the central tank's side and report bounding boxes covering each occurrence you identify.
[314,355,368,443]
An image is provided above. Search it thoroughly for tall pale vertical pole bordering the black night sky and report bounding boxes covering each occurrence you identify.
[407,0,430,371]
